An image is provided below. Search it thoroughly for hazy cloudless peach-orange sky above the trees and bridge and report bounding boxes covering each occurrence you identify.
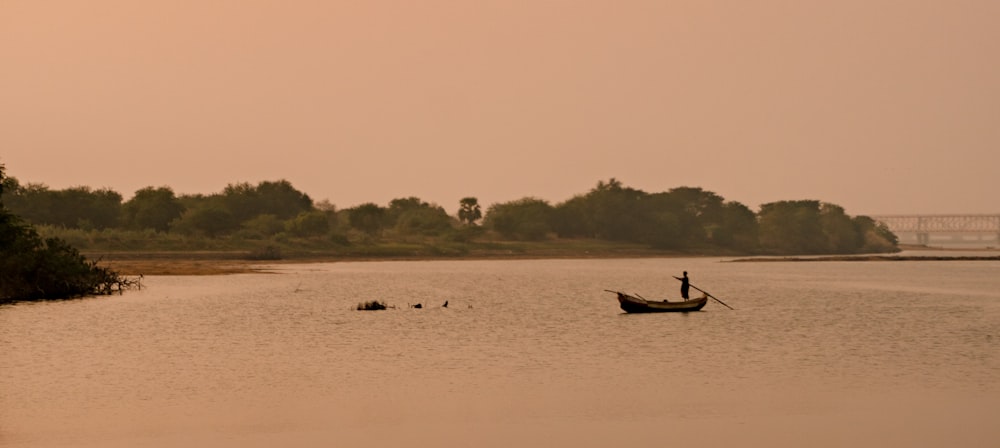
[0,0,1000,214]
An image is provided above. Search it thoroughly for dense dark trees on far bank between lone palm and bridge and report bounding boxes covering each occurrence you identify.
[484,178,898,254]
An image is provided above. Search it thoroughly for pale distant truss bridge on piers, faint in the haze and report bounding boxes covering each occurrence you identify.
[870,214,1000,244]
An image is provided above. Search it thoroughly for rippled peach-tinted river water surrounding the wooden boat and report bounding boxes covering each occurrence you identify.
[0,258,1000,447]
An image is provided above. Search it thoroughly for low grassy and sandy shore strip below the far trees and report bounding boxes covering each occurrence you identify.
[52,227,928,276]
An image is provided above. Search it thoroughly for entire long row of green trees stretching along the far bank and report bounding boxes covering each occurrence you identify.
[4,172,897,254]
